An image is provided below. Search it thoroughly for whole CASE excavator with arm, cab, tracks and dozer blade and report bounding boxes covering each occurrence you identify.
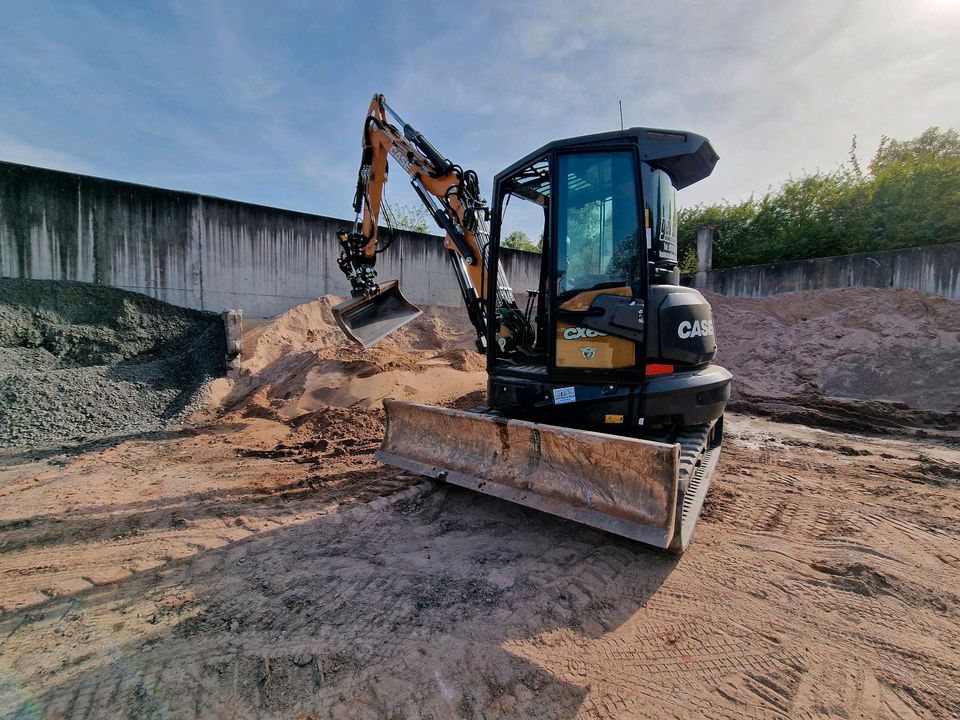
[334,95,731,552]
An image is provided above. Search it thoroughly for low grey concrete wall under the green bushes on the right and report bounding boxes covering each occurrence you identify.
[692,243,960,300]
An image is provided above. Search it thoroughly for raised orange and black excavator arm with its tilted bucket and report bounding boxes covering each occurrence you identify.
[334,94,516,350]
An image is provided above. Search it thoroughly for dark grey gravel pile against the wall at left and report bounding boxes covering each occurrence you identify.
[0,278,225,448]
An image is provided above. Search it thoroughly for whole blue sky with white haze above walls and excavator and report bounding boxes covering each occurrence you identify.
[0,0,960,225]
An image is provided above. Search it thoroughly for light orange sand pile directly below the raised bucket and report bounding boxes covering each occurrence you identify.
[220,296,486,426]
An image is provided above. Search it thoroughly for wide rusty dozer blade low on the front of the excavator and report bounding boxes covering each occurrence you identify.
[375,399,716,550]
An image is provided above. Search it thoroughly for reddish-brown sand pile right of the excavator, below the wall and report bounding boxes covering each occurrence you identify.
[705,289,960,424]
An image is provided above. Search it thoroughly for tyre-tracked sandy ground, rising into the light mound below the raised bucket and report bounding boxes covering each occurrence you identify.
[0,290,960,720]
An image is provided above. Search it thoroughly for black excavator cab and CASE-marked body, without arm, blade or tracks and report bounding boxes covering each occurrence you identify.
[487,128,730,434]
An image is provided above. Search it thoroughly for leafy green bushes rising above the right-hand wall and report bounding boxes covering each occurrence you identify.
[678,127,960,268]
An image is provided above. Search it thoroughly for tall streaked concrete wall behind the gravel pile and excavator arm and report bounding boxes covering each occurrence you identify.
[0,162,540,317]
